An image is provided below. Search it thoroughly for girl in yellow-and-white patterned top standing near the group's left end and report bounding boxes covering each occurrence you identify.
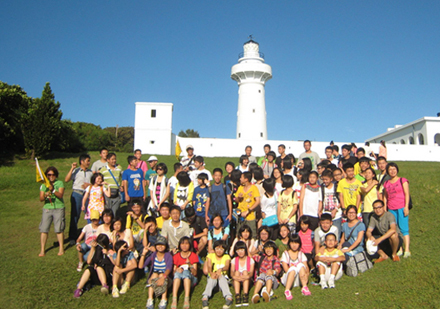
[81,173,110,223]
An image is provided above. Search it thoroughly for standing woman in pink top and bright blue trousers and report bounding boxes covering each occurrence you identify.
[383,162,411,258]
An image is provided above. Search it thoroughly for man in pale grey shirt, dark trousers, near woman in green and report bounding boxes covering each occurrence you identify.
[64,154,93,246]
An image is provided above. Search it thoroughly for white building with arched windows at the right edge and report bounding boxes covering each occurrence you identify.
[367,117,440,146]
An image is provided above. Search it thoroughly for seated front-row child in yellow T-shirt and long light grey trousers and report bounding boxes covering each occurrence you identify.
[202,240,232,309]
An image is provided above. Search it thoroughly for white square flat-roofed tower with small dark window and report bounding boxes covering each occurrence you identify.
[134,102,174,155]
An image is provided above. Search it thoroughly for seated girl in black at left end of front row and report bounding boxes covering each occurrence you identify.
[73,234,114,298]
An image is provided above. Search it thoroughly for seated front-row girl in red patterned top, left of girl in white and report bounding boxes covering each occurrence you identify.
[252,240,281,304]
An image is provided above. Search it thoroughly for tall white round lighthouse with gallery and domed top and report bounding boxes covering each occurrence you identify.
[231,36,272,140]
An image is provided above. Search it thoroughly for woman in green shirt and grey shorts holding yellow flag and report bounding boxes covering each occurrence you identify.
[39,166,66,256]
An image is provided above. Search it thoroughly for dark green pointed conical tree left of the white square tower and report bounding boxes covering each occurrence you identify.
[22,83,63,160]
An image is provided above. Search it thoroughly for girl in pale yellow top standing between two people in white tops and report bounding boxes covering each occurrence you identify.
[278,175,298,233]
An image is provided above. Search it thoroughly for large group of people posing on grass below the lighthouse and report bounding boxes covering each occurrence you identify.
[40,141,411,309]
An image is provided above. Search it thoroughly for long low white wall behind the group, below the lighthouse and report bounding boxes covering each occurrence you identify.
[173,137,440,162]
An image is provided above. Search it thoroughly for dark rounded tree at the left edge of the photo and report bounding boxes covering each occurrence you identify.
[0,81,30,157]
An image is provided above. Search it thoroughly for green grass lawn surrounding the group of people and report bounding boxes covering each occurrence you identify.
[0,153,440,309]
